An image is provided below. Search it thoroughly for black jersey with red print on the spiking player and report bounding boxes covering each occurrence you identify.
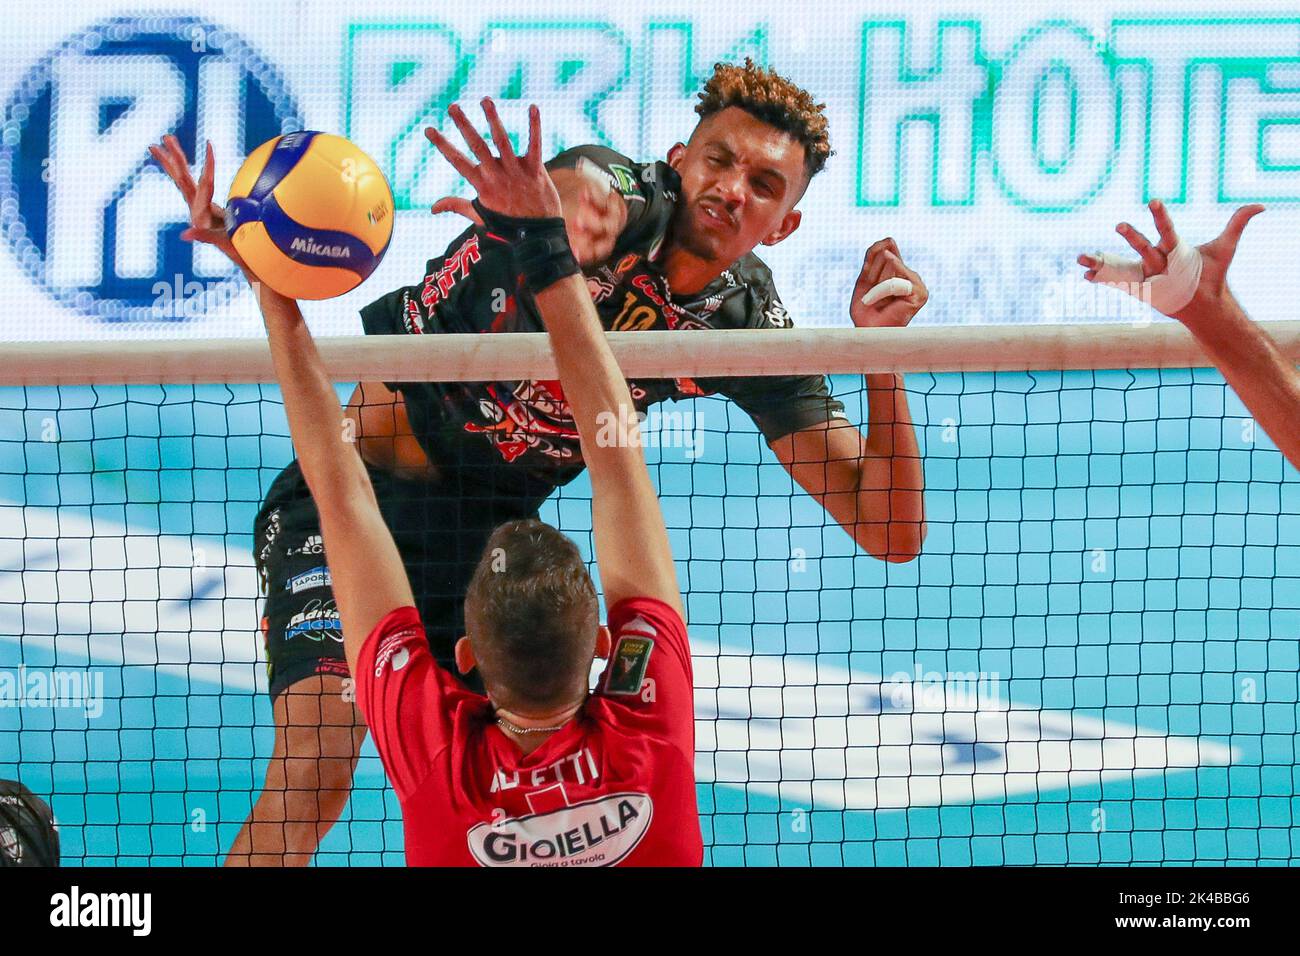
[361,146,844,490]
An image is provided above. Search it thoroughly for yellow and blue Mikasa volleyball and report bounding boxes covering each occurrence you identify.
[226,130,393,299]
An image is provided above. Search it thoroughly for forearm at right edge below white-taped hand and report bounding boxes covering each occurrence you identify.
[1183,293,1300,468]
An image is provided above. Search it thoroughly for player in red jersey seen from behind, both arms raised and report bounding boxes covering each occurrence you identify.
[187,100,703,866]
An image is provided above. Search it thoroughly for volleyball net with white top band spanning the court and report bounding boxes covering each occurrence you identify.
[0,323,1300,865]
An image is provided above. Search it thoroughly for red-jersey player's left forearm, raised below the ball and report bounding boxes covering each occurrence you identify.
[254,277,373,512]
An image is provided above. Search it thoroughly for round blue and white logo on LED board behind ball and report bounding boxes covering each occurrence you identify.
[0,17,302,321]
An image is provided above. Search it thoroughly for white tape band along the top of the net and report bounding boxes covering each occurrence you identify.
[0,321,1300,386]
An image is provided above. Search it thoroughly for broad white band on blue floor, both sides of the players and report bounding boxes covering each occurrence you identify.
[0,507,1234,809]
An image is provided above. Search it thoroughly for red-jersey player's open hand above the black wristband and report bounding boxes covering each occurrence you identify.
[424,98,563,221]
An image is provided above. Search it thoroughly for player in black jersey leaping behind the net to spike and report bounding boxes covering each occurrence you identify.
[152,61,927,864]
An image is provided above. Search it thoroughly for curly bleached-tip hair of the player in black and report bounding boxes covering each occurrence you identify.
[696,56,833,178]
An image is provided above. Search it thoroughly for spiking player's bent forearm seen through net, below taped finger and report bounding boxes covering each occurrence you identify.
[858,373,926,561]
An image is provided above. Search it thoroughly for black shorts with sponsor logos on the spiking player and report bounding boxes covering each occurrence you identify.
[254,460,549,700]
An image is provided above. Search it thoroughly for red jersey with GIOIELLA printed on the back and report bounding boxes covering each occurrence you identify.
[356,597,705,866]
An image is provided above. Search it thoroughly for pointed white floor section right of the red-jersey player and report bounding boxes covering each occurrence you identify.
[693,643,1234,810]
